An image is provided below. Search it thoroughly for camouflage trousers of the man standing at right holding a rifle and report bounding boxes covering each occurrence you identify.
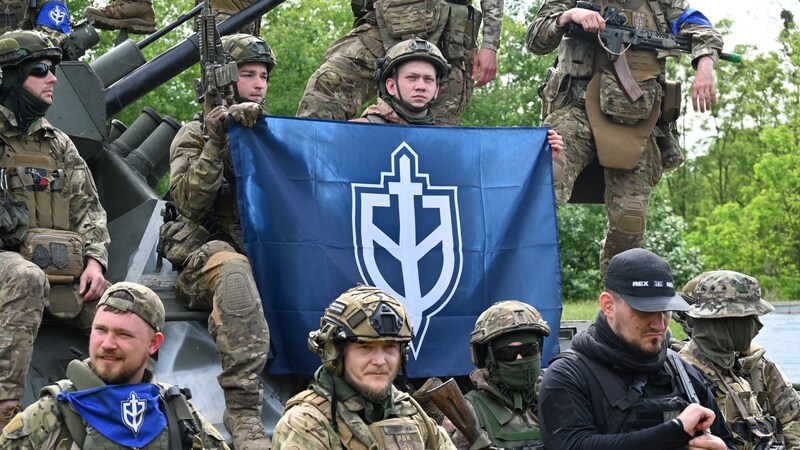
[545,106,662,274]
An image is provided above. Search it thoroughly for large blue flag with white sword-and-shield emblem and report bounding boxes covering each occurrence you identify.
[230,117,561,377]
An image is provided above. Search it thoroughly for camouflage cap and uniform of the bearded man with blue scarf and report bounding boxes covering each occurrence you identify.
[0,282,228,450]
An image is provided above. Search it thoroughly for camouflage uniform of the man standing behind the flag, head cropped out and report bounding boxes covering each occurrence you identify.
[297,0,503,125]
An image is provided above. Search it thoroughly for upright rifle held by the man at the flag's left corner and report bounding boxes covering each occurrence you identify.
[194,0,239,128]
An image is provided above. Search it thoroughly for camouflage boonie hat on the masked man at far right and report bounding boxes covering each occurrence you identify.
[687,270,775,319]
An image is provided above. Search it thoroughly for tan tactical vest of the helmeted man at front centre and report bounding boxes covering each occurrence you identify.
[284,385,435,450]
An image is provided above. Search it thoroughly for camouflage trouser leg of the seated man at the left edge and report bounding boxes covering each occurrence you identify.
[0,252,50,400]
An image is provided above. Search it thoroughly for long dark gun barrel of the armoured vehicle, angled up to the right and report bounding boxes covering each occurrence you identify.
[105,0,284,117]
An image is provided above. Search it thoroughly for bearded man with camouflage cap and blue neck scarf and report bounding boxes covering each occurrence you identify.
[0,283,228,450]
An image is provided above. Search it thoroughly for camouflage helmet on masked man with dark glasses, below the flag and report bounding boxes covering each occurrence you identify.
[469,300,550,367]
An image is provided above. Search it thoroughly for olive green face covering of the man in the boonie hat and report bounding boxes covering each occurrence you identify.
[692,316,762,369]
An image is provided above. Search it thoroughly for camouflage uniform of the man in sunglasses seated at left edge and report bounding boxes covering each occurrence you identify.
[0,31,110,412]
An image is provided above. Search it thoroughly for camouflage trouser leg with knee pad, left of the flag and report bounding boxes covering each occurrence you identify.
[175,241,269,413]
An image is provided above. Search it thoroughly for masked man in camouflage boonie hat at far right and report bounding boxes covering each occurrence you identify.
[680,270,800,450]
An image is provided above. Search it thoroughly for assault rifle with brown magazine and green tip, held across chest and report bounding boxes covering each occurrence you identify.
[566,1,742,102]
